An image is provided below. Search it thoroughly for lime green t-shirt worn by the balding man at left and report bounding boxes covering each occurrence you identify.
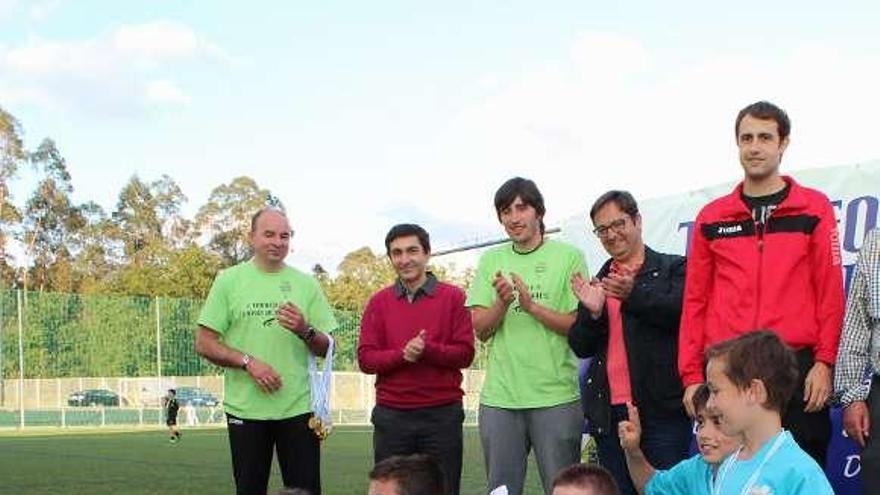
[199,261,336,419]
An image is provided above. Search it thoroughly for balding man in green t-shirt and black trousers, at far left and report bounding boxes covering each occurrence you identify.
[196,208,336,495]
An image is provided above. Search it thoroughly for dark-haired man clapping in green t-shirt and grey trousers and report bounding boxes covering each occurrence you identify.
[466,177,586,495]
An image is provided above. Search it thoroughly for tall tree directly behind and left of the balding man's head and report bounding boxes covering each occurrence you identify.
[195,177,269,266]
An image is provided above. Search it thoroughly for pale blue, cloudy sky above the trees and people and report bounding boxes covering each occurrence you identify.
[0,0,880,267]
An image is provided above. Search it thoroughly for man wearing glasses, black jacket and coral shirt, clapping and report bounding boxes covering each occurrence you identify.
[568,191,691,495]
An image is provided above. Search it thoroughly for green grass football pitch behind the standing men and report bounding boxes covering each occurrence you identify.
[0,428,541,495]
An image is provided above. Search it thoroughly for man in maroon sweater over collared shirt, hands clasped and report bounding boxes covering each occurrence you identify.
[358,224,474,495]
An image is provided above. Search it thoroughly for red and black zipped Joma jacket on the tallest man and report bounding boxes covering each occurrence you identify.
[678,177,844,386]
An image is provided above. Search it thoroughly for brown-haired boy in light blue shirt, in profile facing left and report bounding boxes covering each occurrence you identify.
[704,330,834,495]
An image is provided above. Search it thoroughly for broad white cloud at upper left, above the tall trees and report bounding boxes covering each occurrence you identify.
[0,21,232,115]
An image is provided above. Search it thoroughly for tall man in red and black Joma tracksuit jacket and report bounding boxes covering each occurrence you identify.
[678,101,844,467]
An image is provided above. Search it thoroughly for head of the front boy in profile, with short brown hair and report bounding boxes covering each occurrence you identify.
[706,330,798,437]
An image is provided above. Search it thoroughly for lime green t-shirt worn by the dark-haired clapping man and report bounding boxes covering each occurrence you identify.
[466,239,587,409]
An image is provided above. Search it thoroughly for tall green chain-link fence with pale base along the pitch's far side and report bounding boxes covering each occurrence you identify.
[0,291,483,428]
